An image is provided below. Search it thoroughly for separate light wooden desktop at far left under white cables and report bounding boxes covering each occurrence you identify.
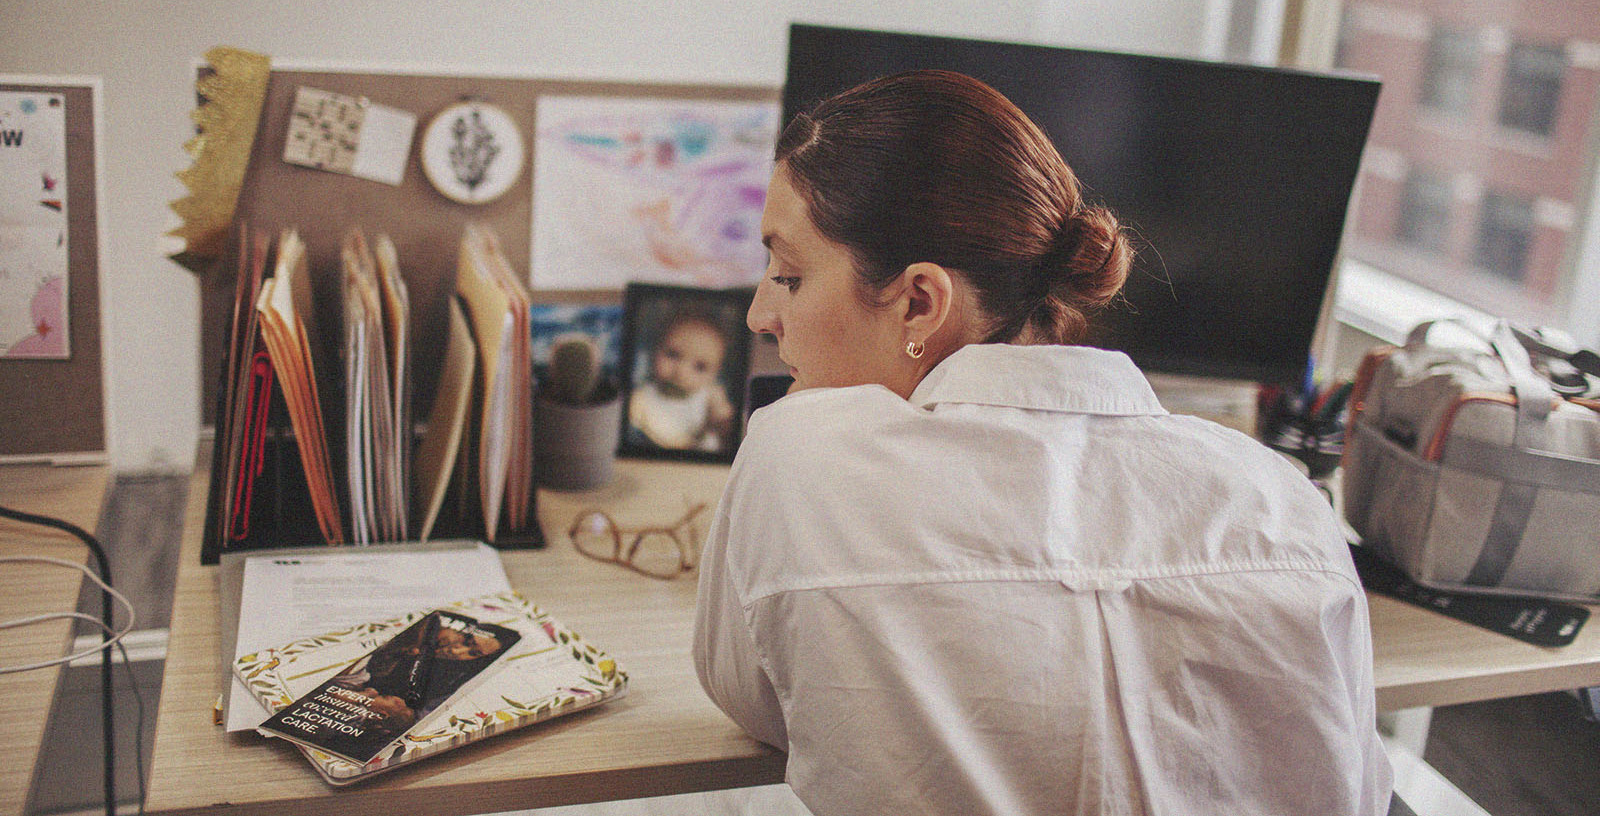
[0,464,106,814]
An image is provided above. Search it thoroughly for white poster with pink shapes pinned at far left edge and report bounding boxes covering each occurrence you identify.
[0,91,70,360]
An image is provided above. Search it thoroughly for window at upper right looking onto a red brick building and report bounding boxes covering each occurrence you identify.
[1331,0,1600,337]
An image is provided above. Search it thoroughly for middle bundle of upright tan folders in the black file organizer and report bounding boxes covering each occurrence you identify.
[341,230,410,544]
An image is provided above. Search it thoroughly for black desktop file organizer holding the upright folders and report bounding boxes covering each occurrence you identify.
[200,251,546,565]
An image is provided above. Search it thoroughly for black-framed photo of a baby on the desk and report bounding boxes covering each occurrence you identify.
[619,283,750,462]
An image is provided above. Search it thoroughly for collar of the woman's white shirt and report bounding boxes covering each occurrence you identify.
[910,344,1166,416]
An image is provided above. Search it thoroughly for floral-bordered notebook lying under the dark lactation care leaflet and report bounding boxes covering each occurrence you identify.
[234,592,627,786]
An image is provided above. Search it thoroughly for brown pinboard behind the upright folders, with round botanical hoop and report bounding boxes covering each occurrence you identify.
[202,69,779,424]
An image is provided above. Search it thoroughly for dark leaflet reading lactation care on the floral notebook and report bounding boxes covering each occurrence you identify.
[259,610,522,765]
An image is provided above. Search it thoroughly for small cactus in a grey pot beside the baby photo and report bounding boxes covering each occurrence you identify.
[533,334,622,490]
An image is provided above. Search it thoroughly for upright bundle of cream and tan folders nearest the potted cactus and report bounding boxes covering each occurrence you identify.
[456,226,533,541]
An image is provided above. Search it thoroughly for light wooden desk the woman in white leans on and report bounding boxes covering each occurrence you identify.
[146,461,1600,816]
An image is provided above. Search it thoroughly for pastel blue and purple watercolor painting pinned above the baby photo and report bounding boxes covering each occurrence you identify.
[531,96,778,290]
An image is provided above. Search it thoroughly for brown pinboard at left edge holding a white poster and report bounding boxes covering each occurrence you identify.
[0,75,106,462]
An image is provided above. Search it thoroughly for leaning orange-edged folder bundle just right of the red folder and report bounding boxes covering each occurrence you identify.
[256,230,344,544]
